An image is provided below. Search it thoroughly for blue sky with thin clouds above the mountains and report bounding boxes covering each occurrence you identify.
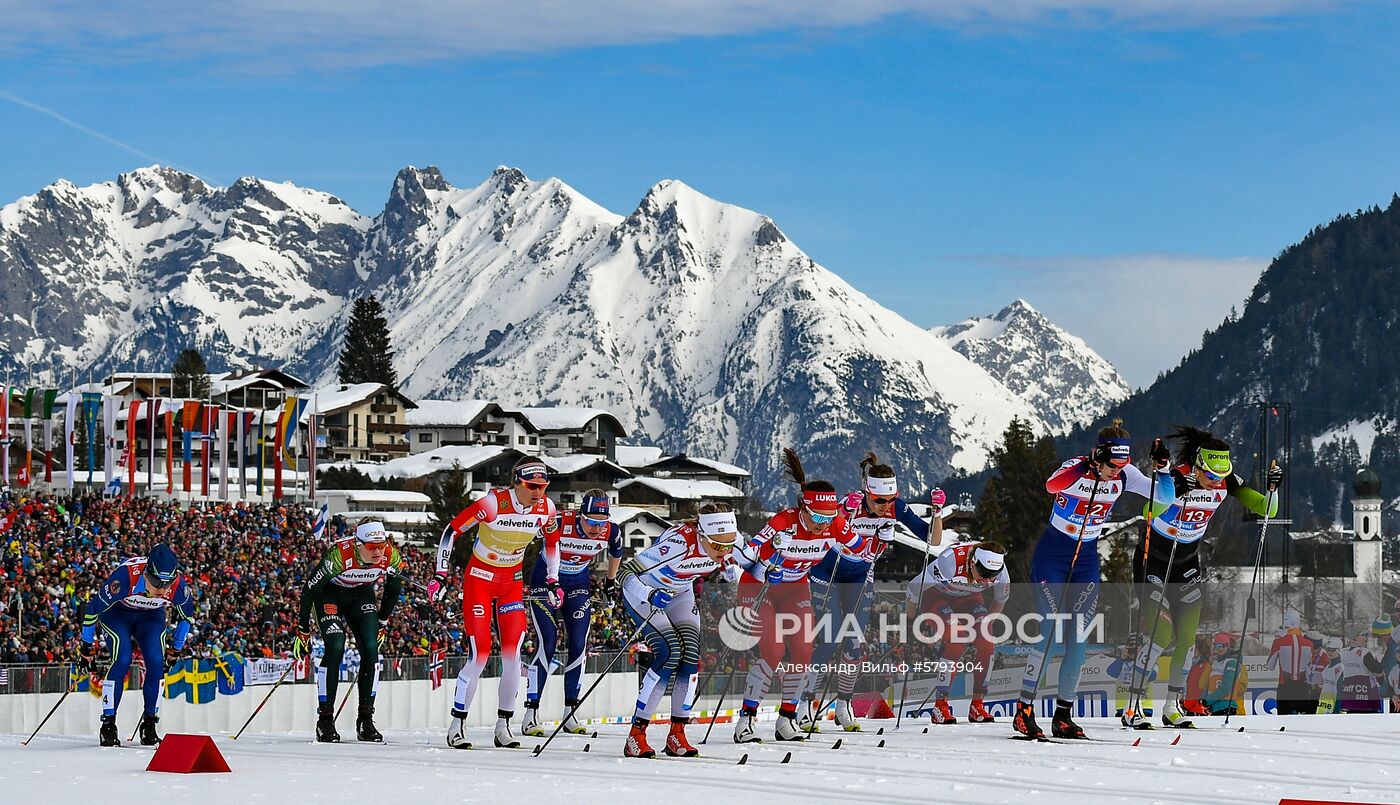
[0,0,1400,385]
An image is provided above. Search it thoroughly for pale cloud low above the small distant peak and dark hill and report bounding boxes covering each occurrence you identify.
[948,253,1268,386]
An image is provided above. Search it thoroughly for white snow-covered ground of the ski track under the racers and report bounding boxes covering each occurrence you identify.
[0,715,1400,805]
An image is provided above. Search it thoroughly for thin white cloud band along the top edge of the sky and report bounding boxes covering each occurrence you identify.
[0,0,1347,69]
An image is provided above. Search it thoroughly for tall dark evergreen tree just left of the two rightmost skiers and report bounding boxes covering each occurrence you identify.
[977,419,1060,581]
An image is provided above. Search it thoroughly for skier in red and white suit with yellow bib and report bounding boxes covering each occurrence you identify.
[428,456,564,749]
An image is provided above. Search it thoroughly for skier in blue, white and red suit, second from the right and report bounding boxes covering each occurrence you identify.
[1012,420,1172,738]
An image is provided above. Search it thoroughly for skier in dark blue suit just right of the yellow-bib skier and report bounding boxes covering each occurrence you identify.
[521,489,622,736]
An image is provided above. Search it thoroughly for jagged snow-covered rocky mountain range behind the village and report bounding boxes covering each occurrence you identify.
[0,168,1121,503]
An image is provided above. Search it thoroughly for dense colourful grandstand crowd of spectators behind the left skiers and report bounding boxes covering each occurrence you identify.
[0,491,739,665]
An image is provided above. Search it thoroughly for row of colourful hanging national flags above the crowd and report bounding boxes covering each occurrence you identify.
[0,384,316,500]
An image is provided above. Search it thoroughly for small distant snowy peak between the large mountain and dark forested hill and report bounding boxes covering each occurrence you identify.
[931,300,1131,434]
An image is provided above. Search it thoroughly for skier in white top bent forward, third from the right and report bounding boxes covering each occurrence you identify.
[906,542,1011,724]
